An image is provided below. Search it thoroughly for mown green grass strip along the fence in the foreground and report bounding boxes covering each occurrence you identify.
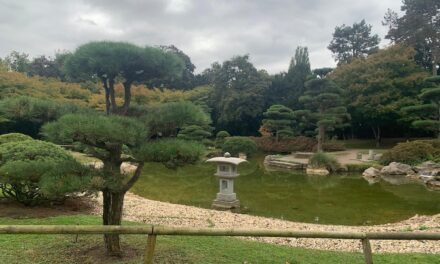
[0,215,440,264]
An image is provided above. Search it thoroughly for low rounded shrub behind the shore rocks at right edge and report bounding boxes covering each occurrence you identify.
[380,140,440,165]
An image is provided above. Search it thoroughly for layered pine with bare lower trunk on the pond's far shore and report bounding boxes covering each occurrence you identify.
[294,78,349,152]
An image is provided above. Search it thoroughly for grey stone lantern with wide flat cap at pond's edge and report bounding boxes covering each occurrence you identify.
[206,152,246,210]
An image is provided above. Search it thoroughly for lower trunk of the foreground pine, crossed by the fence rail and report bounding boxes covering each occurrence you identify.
[102,189,125,256]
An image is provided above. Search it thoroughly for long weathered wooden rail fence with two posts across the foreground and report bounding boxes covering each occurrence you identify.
[0,225,440,264]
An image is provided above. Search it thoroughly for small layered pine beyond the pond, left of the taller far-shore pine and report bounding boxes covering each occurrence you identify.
[263,105,295,142]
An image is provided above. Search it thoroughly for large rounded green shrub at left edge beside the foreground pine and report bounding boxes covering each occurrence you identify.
[0,140,89,205]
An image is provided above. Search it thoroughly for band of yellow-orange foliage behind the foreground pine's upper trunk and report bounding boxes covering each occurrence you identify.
[0,71,212,111]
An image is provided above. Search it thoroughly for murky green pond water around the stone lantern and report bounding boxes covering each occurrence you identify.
[131,157,440,225]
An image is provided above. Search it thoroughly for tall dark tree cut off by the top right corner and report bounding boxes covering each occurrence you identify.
[383,0,440,75]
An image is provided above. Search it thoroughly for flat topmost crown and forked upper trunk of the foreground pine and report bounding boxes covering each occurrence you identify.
[65,41,184,115]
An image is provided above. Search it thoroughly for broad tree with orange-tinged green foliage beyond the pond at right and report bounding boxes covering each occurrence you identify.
[328,45,426,145]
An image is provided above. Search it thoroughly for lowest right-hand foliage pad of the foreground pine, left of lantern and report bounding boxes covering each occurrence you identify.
[140,139,205,168]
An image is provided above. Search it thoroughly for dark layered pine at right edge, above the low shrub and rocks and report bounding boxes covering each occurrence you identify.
[402,76,440,139]
